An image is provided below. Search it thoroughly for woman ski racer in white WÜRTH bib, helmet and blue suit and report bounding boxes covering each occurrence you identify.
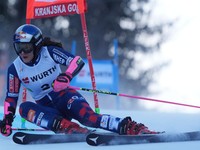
[0,24,156,136]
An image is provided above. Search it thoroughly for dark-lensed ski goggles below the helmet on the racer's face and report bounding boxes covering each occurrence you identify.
[14,43,34,54]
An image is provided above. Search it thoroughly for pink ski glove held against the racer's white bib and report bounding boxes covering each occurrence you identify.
[53,73,72,92]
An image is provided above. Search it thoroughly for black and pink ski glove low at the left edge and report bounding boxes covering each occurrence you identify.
[0,113,14,136]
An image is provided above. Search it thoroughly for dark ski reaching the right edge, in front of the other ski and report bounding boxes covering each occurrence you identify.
[86,131,200,146]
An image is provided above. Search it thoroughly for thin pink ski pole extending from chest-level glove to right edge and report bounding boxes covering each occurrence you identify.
[69,86,200,108]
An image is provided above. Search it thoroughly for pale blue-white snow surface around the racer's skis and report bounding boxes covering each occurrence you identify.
[0,109,200,150]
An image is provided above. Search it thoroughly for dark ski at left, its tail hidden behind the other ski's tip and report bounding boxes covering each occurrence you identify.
[13,132,86,145]
